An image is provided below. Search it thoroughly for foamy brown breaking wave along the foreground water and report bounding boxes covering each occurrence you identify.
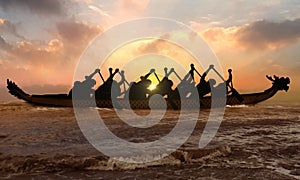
[0,146,231,174]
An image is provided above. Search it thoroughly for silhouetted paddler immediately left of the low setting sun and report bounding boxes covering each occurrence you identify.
[129,69,155,100]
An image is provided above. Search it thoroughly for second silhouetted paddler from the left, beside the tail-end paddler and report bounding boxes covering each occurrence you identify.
[95,68,123,100]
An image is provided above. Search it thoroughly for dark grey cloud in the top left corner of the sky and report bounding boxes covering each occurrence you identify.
[0,0,63,15]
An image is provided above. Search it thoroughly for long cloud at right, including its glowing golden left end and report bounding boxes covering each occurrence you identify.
[201,19,300,50]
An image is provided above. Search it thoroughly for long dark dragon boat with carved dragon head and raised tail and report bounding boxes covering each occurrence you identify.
[7,76,290,109]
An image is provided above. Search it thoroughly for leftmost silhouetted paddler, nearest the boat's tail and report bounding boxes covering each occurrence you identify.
[68,69,100,100]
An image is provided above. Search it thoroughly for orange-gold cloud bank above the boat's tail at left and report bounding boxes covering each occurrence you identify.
[0,20,102,84]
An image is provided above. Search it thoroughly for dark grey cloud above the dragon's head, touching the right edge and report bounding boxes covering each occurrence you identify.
[236,19,300,49]
